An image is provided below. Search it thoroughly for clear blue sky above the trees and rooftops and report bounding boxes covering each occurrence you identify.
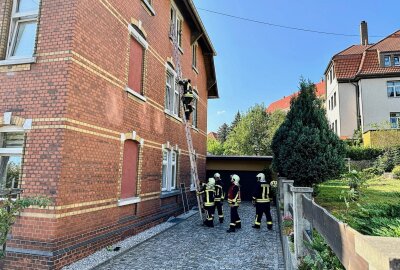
[194,0,400,131]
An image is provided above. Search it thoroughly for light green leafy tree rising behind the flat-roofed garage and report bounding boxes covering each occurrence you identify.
[225,104,270,155]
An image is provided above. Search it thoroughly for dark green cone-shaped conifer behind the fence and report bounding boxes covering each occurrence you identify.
[272,80,345,186]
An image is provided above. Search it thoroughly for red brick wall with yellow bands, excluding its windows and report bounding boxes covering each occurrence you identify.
[0,0,212,269]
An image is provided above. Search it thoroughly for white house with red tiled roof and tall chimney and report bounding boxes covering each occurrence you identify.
[325,22,400,142]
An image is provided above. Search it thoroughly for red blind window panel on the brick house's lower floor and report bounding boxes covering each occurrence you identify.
[121,140,139,199]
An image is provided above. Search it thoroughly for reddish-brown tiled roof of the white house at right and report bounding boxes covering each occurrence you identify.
[332,31,400,80]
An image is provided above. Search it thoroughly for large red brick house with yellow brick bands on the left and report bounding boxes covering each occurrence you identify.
[0,0,218,270]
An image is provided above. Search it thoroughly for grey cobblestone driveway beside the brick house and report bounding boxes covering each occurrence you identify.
[96,203,285,270]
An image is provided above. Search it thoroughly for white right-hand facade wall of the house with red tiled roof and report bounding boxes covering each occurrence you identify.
[359,77,400,132]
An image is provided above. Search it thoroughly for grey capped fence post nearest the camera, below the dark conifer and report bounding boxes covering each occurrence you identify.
[290,186,313,258]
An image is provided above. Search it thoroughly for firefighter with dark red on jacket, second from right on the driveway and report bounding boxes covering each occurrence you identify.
[227,174,242,233]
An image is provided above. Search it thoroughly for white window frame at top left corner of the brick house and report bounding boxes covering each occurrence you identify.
[6,0,40,62]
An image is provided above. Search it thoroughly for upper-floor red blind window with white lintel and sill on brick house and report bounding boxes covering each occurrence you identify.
[126,25,148,100]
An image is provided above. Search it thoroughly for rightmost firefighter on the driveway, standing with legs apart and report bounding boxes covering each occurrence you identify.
[253,173,272,230]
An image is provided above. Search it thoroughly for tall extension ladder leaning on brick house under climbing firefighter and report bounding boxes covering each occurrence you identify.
[170,21,203,221]
